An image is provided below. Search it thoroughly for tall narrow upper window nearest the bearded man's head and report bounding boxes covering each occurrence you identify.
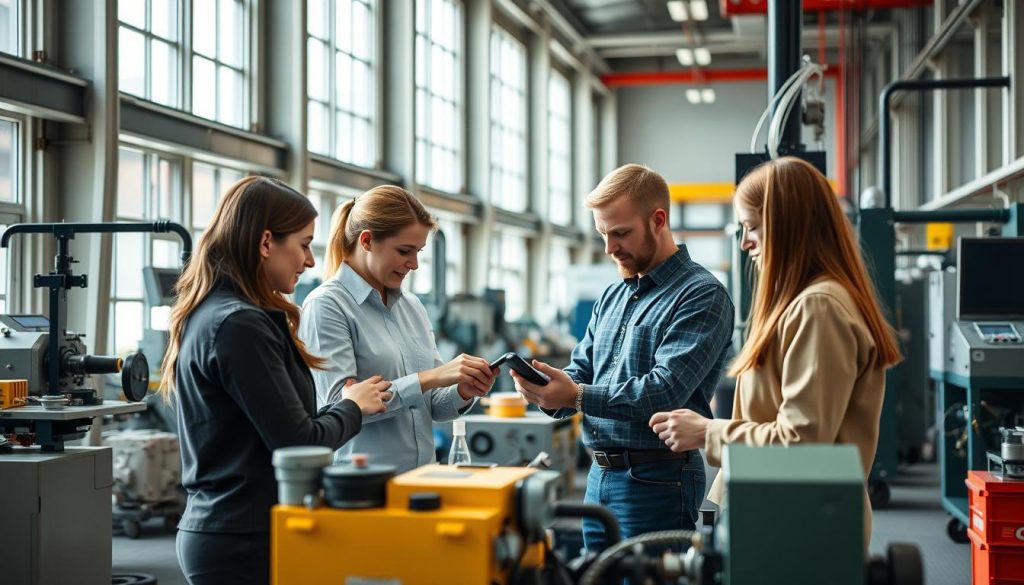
[548,71,572,225]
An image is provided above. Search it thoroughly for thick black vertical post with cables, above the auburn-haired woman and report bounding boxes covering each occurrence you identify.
[768,0,804,152]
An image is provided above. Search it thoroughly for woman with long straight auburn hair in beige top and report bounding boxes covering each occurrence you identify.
[650,157,902,542]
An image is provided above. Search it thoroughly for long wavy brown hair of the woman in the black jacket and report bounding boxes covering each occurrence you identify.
[160,176,324,399]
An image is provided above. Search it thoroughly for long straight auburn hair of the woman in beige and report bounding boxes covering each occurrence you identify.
[729,157,902,376]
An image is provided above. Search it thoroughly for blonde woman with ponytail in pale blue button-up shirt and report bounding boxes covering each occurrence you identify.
[299,185,497,472]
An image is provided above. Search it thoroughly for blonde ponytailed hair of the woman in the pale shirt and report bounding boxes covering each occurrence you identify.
[324,184,437,279]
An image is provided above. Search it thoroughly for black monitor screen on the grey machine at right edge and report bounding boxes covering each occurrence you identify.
[956,238,1024,321]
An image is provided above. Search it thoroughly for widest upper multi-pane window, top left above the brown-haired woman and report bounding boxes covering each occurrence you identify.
[119,0,252,129]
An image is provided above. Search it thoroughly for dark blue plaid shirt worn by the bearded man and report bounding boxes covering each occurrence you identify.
[549,246,733,450]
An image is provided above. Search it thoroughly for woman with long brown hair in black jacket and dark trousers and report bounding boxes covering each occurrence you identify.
[160,177,390,585]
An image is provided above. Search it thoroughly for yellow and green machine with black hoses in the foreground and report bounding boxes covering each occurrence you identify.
[270,446,923,585]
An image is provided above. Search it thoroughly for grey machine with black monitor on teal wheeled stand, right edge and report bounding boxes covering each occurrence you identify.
[937,238,1024,542]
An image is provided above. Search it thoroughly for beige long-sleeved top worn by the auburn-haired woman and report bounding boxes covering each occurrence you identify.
[705,280,886,541]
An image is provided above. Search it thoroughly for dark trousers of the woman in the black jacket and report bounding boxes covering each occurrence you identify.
[176,530,270,585]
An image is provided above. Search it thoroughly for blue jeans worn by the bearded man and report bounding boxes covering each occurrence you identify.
[583,451,706,552]
